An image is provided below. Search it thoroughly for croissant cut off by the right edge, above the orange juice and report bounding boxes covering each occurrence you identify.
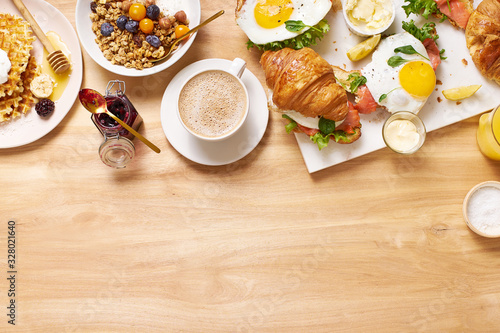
[465,0,500,84]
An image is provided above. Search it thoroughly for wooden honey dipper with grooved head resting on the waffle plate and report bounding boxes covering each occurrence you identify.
[12,0,71,74]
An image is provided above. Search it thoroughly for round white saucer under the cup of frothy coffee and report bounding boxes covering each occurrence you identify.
[161,59,269,165]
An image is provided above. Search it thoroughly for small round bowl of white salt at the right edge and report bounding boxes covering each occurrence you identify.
[463,181,500,238]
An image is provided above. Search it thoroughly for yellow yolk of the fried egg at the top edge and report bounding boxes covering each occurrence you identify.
[254,0,293,29]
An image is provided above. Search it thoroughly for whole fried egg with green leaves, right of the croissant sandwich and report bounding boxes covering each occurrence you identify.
[361,32,436,114]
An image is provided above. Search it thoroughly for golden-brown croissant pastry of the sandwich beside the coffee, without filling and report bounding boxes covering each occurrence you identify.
[260,48,349,121]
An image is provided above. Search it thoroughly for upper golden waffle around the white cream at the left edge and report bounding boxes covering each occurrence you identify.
[0,13,36,98]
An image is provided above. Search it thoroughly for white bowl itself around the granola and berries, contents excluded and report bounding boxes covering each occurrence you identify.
[75,0,201,77]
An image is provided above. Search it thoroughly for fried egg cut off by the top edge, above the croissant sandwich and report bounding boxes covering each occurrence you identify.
[236,0,332,44]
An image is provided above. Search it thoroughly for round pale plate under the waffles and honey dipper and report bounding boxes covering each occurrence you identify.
[0,0,83,148]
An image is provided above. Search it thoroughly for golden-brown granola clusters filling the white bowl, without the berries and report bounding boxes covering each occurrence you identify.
[90,0,187,70]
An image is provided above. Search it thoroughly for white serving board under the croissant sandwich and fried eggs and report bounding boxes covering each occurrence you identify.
[296,0,500,173]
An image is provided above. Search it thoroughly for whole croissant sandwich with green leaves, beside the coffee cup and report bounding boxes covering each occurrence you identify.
[260,47,361,149]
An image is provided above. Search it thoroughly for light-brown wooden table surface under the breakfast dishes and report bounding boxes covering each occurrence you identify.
[0,0,500,332]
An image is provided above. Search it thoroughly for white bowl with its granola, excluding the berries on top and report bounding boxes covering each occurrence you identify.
[75,0,201,77]
